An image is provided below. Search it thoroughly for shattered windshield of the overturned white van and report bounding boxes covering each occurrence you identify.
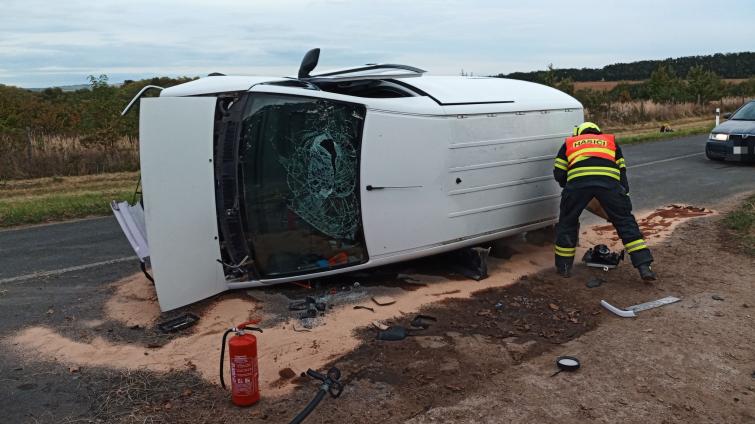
[239,93,367,277]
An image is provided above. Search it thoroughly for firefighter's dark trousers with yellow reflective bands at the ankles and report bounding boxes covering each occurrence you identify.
[554,186,653,269]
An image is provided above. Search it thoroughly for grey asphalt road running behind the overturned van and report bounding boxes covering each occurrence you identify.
[0,135,755,422]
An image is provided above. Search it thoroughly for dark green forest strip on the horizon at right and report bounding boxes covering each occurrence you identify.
[497,52,755,82]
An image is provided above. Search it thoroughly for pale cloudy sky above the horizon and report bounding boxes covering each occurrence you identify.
[0,0,755,87]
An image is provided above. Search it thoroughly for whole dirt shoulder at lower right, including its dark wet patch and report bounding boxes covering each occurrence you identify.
[322,200,755,423]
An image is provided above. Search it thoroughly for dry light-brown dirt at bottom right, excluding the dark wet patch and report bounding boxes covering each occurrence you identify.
[411,217,755,423]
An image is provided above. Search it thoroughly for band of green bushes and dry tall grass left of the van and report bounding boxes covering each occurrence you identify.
[0,75,191,179]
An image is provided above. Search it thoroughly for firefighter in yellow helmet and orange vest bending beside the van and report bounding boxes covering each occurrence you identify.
[553,122,656,281]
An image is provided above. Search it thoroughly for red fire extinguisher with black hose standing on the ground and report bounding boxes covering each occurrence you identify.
[220,320,262,406]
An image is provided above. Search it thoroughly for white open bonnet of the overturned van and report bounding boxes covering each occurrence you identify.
[139,97,227,311]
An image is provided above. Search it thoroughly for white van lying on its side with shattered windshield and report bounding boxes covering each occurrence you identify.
[113,52,583,311]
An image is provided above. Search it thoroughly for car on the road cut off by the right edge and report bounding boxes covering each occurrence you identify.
[705,100,755,162]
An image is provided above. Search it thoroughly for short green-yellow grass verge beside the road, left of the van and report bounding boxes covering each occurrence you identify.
[0,172,138,227]
